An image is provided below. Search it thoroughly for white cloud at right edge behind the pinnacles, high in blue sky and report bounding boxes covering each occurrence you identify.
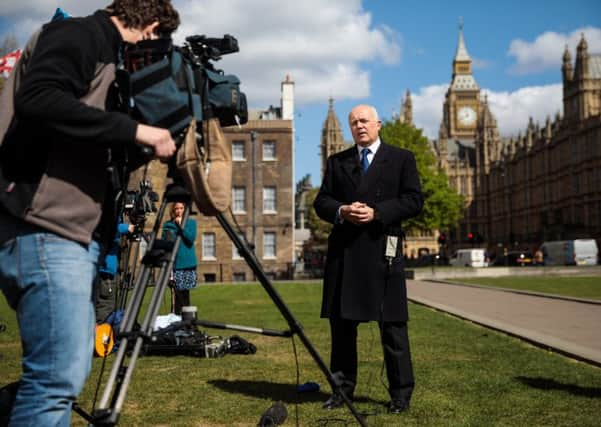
[507,27,601,74]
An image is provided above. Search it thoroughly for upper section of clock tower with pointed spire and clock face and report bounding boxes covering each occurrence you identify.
[442,21,481,140]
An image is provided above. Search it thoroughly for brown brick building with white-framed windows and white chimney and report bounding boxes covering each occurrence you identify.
[140,77,295,283]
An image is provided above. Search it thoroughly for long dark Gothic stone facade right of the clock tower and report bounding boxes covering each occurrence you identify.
[482,36,601,248]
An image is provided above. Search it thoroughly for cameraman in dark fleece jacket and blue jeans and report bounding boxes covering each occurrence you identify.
[0,0,179,426]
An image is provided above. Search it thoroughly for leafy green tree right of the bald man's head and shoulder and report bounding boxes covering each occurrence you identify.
[380,121,463,234]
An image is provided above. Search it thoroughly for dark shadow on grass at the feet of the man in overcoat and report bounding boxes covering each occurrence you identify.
[208,380,386,405]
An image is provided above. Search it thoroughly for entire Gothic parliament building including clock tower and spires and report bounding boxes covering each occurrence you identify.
[321,27,601,253]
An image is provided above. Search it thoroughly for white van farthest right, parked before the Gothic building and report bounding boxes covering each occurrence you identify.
[540,239,599,265]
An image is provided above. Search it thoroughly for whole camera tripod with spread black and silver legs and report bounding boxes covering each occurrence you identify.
[74,184,367,426]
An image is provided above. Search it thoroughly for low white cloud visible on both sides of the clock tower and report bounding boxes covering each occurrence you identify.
[411,84,563,139]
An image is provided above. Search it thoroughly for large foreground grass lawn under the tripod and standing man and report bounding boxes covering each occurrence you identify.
[0,279,601,426]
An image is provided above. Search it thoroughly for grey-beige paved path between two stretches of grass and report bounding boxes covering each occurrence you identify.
[407,280,601,366]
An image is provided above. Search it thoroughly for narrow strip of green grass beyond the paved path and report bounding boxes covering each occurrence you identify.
[452,276,601,300]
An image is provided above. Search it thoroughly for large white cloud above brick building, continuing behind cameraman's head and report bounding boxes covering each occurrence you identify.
[0,0,401,107]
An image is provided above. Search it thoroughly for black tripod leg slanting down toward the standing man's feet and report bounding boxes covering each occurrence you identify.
[216,213,367,426]
